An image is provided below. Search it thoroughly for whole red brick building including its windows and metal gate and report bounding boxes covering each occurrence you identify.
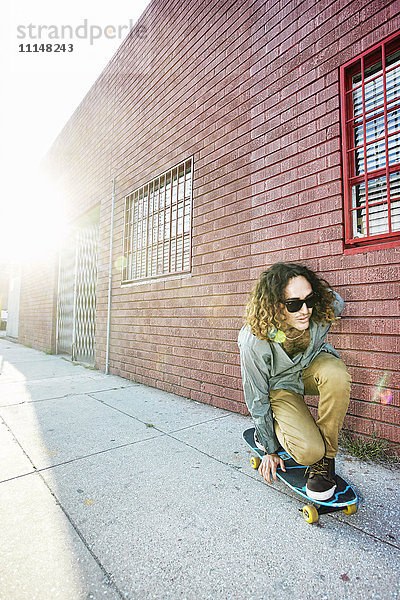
[15,0,400,448]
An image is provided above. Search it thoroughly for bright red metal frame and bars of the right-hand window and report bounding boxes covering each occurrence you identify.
[340,32,400,252]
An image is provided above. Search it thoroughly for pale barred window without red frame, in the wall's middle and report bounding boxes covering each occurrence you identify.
[122,158,193,282]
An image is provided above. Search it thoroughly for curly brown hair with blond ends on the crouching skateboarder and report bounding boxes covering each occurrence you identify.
[245,263,337,341]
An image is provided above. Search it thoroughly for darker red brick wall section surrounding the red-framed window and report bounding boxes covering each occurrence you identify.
[247,2,400,445]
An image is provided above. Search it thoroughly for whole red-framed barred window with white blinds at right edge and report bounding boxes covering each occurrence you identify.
[340,33,400,249]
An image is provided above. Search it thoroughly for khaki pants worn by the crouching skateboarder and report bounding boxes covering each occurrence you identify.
[270,352,351,465]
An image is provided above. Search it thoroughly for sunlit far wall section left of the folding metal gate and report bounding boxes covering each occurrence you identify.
[18,257,57,352]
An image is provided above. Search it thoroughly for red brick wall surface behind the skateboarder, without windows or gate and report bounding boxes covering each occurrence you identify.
[41,0,400,444]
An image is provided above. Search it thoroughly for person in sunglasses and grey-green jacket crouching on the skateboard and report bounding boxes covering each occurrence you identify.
[238,263,351,501]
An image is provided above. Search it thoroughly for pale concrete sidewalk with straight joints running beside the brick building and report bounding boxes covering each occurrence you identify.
[0,339,400,600]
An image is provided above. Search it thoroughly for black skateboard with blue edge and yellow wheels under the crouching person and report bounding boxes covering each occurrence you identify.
[243,428,358,523]
